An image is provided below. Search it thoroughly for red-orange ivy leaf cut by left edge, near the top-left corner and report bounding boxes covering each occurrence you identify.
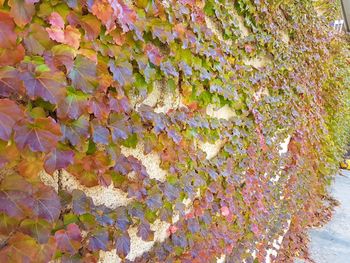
[0,12,17,48]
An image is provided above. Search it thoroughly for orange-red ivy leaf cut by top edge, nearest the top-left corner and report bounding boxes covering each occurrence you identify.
[8,0,35,28]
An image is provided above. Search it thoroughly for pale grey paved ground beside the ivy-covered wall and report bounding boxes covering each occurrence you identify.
[295,170,350,263]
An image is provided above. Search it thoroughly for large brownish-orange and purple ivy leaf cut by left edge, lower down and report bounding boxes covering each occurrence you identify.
[0,174,33,218]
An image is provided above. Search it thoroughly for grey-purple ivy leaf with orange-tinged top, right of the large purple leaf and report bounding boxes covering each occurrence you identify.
[61,115,90,146]
